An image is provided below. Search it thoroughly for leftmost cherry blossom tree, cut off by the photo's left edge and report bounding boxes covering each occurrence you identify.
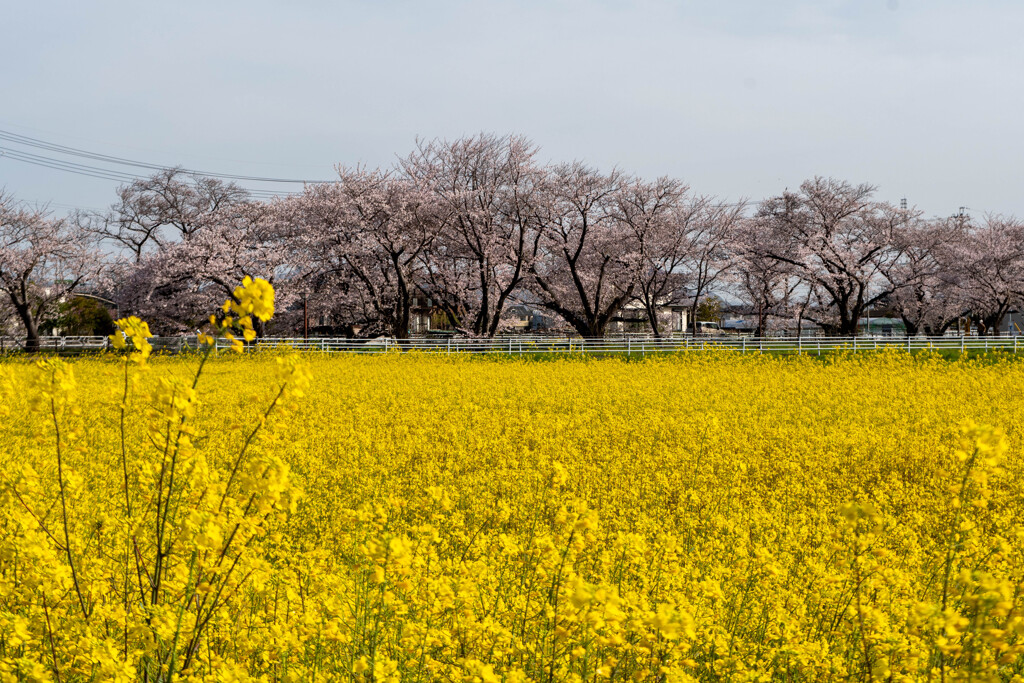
[0,194,103,352]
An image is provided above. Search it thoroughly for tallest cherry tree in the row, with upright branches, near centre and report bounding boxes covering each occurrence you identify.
[402,133,541,337]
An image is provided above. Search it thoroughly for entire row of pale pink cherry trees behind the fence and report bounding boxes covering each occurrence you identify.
[6,134,1024,348]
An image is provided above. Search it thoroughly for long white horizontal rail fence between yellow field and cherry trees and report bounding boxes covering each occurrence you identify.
[0,335,1024,355]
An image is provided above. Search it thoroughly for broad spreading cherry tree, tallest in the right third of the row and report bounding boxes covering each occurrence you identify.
[757,177,906,335]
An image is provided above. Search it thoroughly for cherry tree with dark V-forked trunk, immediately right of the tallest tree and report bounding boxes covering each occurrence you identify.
[528,162,639,337]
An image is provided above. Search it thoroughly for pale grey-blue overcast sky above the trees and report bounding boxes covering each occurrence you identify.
[0,0,1024,216]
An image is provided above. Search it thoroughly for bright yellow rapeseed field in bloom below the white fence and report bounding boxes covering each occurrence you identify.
[0,282,1024,682]
